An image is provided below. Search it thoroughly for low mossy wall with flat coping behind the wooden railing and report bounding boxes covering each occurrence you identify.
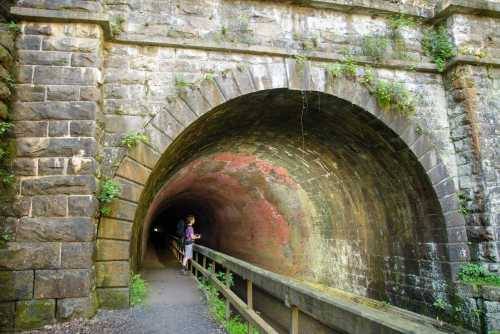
[194,245,472,334]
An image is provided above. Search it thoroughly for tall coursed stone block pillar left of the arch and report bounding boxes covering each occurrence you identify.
[0,22,102,329]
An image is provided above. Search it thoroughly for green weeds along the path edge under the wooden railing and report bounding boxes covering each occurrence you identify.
[198,265,259,334]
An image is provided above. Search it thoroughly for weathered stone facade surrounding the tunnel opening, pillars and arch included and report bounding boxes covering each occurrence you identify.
[0,0,500,330]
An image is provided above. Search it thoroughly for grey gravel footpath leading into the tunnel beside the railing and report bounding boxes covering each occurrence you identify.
[23,252,226,334]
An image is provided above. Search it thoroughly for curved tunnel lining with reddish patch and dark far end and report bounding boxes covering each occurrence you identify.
[135,89,446,311]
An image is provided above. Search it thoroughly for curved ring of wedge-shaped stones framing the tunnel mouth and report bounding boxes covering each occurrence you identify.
[96,60,468,307]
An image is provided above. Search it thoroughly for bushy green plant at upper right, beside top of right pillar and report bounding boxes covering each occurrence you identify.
[422,26,456,72]
